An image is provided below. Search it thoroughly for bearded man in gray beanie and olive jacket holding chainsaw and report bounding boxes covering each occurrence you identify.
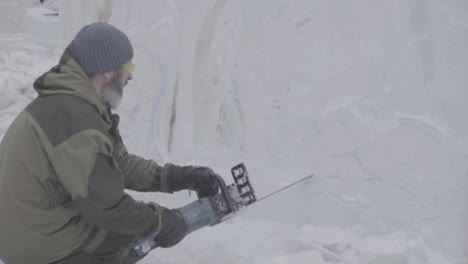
[0,23,218,264]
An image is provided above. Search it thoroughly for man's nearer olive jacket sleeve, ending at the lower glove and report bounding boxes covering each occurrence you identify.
[50,130,160,236]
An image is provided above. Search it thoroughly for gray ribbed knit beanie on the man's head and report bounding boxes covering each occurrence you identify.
[73,22,133,76]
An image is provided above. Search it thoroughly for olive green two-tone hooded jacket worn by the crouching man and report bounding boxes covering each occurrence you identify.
[0,45,174,264]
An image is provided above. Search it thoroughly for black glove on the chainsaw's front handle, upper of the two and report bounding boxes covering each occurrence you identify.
[167,166,219,198]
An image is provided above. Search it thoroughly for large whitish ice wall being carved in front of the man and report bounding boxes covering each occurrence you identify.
[59,0,468,260]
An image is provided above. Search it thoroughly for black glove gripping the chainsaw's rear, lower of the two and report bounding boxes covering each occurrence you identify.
[154,207,188,248]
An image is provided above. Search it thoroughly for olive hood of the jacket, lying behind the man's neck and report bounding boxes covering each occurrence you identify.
[33,42,111,123]
